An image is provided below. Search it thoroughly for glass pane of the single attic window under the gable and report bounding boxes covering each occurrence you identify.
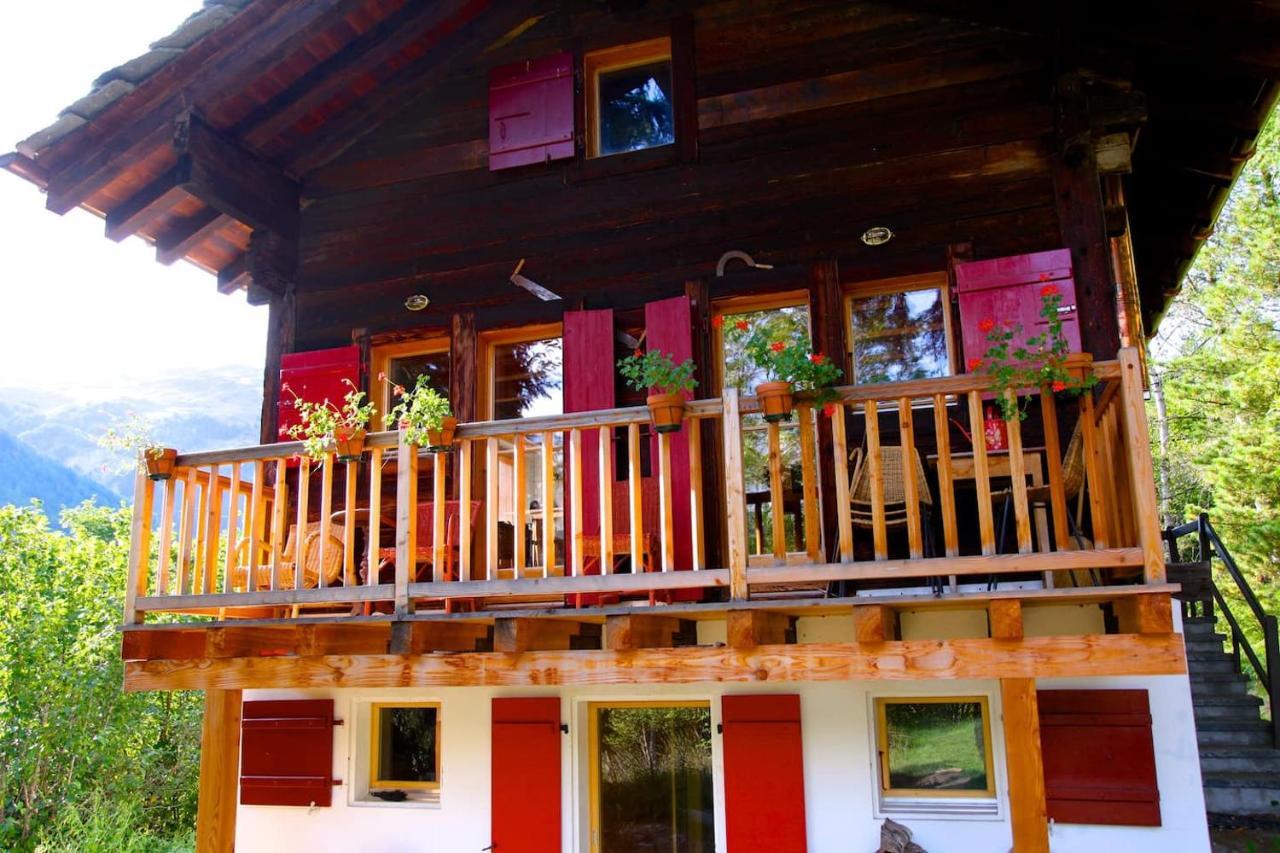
[598,59,676,155]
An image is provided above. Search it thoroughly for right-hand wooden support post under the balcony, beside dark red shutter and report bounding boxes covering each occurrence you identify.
[1000,679,1048,853]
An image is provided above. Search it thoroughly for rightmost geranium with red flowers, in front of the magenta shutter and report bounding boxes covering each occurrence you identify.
[966,284,1097,420]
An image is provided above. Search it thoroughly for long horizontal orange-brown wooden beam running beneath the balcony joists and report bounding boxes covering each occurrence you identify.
[124,630,1187,690]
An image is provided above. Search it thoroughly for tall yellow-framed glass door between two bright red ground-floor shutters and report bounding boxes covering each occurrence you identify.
[589,703,716,853]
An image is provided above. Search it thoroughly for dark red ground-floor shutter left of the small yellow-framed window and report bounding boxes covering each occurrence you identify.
[241,699,333,806]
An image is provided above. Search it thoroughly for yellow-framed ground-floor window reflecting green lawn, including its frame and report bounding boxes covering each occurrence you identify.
[876,695,996,806]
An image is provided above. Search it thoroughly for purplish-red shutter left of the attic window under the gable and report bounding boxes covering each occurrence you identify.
[489,53,573,172]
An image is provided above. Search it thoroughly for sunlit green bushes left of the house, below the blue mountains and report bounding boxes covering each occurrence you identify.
[0,503,201,850]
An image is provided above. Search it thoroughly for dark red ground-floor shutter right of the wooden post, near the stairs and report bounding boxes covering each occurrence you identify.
[1036,690,1160,826]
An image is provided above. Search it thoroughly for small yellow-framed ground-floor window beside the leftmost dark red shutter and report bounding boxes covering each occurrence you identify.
[369,702,440,795]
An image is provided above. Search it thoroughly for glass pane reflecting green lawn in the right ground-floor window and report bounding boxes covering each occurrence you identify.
[882,702,988,792]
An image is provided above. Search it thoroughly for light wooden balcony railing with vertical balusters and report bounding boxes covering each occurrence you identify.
[125,350,1164,624]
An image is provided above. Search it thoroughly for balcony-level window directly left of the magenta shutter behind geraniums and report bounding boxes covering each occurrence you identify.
[845,273,952,384]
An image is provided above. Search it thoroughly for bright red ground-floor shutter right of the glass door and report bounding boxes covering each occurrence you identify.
[721,694,805,853]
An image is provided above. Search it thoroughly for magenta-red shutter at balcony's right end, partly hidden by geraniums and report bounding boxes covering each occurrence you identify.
[956,248,1080,361]
